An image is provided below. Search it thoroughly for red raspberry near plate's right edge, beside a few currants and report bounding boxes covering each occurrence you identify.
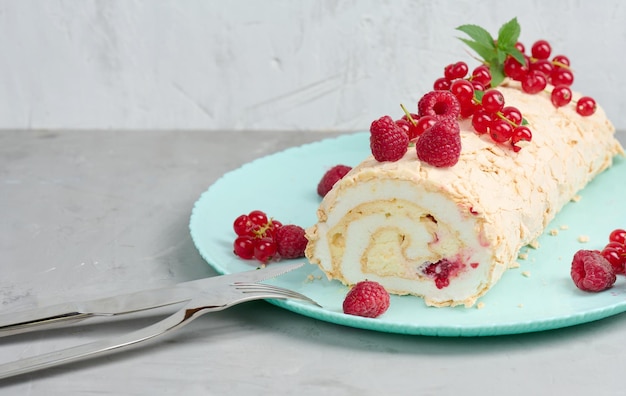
[571,249,616,292]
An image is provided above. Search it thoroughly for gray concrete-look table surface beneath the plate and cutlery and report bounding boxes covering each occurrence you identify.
[0,131,626,395]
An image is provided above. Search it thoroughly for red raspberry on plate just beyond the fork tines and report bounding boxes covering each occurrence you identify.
[343,280,389,318]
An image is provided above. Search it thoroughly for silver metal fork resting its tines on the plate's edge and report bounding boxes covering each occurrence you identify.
[0,266,319,379]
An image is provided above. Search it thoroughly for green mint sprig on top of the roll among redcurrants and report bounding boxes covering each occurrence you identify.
[456,18,525,87]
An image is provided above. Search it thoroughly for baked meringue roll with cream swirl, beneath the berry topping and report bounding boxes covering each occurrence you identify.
[306,83,623,307]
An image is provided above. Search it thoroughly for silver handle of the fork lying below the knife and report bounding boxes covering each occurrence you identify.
[0,306,222,379]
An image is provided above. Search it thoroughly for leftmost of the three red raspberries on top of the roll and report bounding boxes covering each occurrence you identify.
[370,116,409,162]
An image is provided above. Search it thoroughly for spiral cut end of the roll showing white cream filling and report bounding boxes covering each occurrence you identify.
[315,179,499,305]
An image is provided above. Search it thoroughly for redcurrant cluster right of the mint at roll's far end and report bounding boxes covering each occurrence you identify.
[504,40,596,116]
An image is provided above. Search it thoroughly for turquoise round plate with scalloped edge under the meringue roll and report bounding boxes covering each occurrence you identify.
[190,133,626,336]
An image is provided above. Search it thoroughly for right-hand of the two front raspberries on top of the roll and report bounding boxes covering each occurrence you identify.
[415,118,461,168]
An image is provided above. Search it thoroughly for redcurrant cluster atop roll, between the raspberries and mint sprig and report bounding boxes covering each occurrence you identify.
[433,62,532,152]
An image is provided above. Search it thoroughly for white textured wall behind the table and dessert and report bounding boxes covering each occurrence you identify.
[0,0,626,130]
